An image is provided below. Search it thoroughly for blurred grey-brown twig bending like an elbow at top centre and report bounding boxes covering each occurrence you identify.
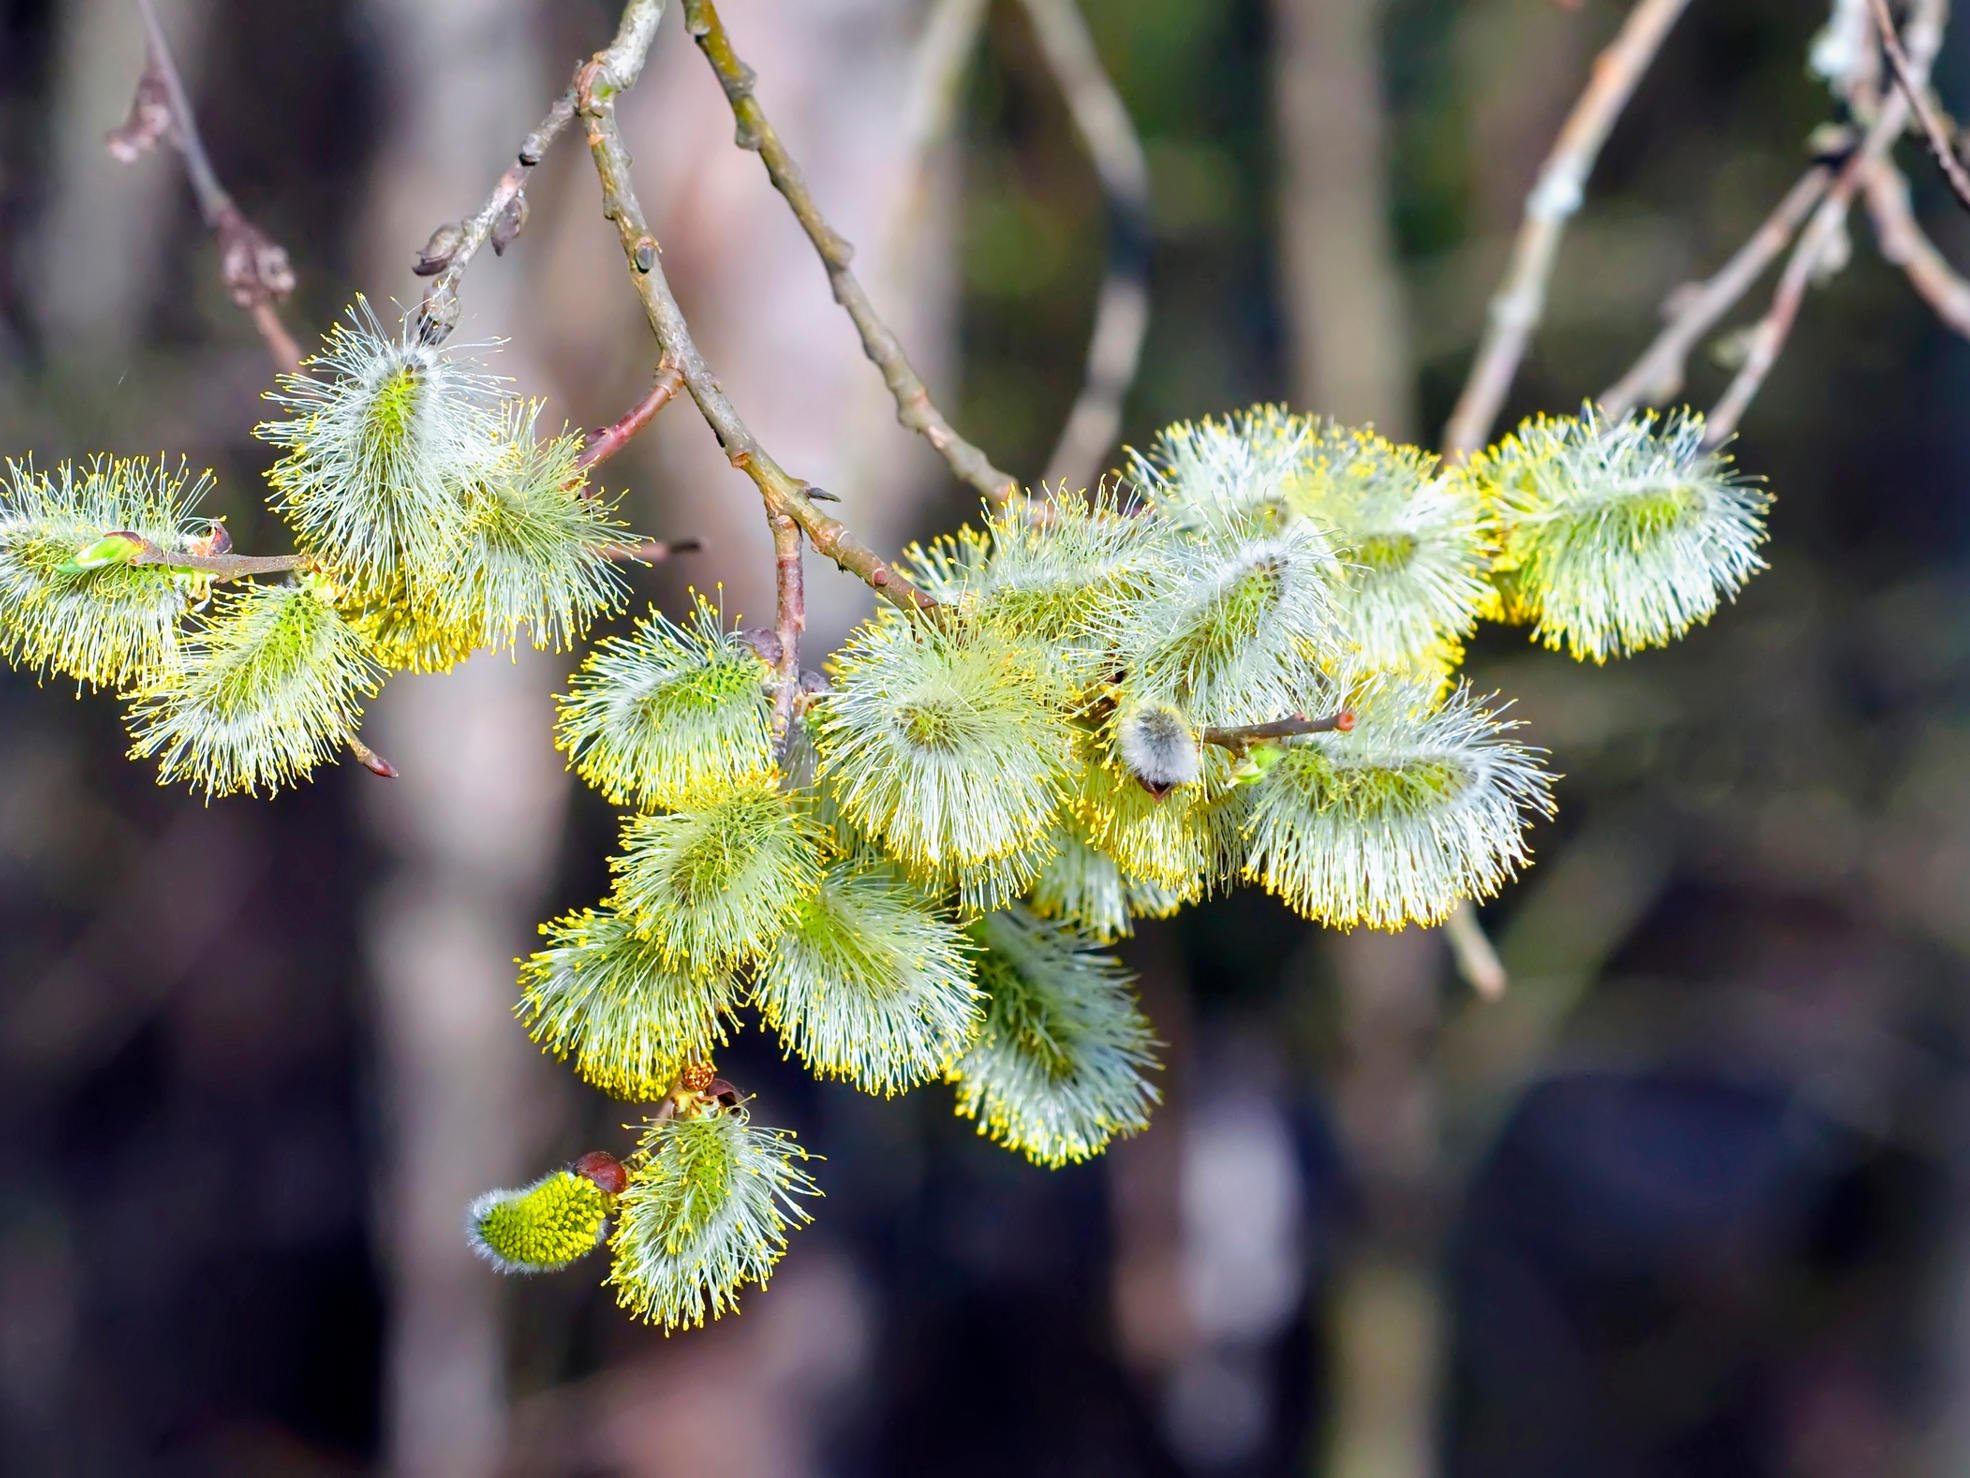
[1020,0,1149,489]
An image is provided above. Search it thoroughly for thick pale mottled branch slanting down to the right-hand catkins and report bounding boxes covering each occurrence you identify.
[1444,0,1690,459]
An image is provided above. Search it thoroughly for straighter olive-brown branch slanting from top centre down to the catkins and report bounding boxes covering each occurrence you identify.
[684,0,1018,508]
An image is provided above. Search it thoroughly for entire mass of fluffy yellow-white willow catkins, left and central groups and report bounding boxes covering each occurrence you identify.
[0,307,1767,1328]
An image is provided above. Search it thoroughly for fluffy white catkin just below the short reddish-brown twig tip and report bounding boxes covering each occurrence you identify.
[1245,682,1552,928]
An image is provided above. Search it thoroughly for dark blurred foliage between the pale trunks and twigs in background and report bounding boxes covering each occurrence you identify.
[0,0,1970,1476]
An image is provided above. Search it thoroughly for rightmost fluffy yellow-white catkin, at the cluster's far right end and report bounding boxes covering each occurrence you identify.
[1464,406,1771,662]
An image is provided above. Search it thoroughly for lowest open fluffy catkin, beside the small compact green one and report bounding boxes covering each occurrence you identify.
[609,1108,820,1330]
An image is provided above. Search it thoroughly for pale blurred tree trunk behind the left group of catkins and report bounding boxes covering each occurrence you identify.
[351,0,577,1474]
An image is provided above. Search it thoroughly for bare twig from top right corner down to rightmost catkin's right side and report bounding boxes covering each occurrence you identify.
[1704,0,1948,447]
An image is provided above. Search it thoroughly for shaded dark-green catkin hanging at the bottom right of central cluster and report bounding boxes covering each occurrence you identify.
[952,910,1158,1165]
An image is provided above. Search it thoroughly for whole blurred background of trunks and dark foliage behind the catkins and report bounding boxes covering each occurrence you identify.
[0,0,1970,1478]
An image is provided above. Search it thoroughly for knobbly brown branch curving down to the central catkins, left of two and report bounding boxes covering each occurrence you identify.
[575,37,938,611]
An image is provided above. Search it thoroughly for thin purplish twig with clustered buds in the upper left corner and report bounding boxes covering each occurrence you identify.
[120,0,301,370]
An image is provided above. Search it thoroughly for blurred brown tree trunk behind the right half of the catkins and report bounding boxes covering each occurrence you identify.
[1273,0,1444,1478]
